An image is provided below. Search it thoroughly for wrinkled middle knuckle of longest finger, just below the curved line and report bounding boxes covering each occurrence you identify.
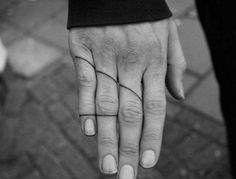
[120,101,143,123]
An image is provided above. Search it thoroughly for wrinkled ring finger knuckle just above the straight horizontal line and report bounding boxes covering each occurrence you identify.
[96,95,118,114]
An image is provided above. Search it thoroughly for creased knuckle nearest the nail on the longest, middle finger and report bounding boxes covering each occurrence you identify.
[120,143,139,156]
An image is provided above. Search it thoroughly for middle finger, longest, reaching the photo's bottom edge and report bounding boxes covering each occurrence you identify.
[118,53,143,179]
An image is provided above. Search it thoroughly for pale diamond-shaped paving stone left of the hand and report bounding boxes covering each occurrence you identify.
[8,38,61,77]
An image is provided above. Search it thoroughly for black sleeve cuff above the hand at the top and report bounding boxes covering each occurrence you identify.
[67,0,172,29]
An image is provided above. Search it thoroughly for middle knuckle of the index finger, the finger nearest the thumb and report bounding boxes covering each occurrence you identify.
[144,99,166,115]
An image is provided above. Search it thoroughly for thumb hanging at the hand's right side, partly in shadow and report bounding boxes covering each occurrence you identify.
[166,20,186,100]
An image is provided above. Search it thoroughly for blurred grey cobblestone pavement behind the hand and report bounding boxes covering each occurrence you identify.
[0,0,231,179]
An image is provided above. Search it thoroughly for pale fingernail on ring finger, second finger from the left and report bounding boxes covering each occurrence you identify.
[102,155,117,174]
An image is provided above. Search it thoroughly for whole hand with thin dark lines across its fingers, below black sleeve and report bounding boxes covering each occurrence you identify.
[69,19,186,179]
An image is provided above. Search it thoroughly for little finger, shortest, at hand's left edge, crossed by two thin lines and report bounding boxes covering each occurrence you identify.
[69,31,96,136]
